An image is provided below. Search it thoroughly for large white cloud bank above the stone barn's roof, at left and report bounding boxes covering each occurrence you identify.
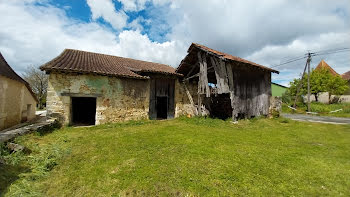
[0,1,185,72]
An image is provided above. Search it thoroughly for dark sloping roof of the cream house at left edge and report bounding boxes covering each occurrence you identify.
[0,52,38,102]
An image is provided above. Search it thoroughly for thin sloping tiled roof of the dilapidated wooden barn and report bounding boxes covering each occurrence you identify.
[176,43,279,73]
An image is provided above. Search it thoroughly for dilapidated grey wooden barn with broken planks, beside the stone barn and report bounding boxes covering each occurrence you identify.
[176,43,279,120]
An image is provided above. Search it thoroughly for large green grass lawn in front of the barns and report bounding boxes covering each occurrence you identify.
[0,118,350,196]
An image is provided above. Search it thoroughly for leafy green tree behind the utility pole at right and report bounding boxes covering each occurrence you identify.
[289,69,348,104]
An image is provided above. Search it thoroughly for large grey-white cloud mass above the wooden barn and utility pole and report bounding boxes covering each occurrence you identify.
[166,0,350,84]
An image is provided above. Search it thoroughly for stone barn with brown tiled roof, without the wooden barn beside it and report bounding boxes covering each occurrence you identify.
[40,49,191,125]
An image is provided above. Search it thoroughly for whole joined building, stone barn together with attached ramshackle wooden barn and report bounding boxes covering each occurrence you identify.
[40,44,278,125]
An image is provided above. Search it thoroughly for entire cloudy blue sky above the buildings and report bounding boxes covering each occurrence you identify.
[0,0,350,85]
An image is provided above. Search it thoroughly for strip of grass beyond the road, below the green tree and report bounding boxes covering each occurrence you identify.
[282,102,350,118]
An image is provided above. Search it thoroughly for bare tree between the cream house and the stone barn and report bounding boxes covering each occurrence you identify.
[23,66,48,109]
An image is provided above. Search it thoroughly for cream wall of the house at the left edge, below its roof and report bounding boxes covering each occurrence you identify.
[0,76,36,130]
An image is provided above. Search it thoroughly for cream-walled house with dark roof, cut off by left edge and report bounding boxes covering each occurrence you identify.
[0,53,38,130]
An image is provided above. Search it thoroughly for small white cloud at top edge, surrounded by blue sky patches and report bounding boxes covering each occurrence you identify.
[87,0,128,30]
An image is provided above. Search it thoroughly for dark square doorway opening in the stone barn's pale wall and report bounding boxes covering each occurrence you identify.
[72,97,96,125]
